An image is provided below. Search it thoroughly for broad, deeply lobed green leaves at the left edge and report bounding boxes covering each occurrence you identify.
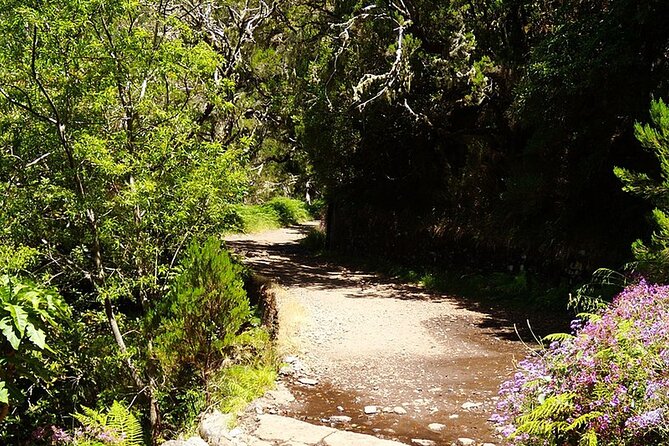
[0,275,70,421]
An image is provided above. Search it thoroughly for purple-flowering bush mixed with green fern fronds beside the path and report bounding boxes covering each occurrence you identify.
[494,281,669,446]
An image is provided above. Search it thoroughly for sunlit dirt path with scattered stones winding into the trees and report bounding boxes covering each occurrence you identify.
[227,227,527,445]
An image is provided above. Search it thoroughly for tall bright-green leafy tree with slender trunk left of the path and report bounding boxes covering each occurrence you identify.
[0,0,246,436]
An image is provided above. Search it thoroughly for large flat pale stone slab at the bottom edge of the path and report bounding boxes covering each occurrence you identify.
[254,415,336,444]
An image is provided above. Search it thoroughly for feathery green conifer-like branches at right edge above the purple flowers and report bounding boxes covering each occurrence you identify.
[614,99,669,282]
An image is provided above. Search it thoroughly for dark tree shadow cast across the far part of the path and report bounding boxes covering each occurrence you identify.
[226,222,571,342]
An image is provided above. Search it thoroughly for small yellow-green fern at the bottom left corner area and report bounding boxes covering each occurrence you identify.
[74,401,144,446]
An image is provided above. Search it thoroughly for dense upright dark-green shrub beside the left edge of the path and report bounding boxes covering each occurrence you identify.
[147,237,251,386]
